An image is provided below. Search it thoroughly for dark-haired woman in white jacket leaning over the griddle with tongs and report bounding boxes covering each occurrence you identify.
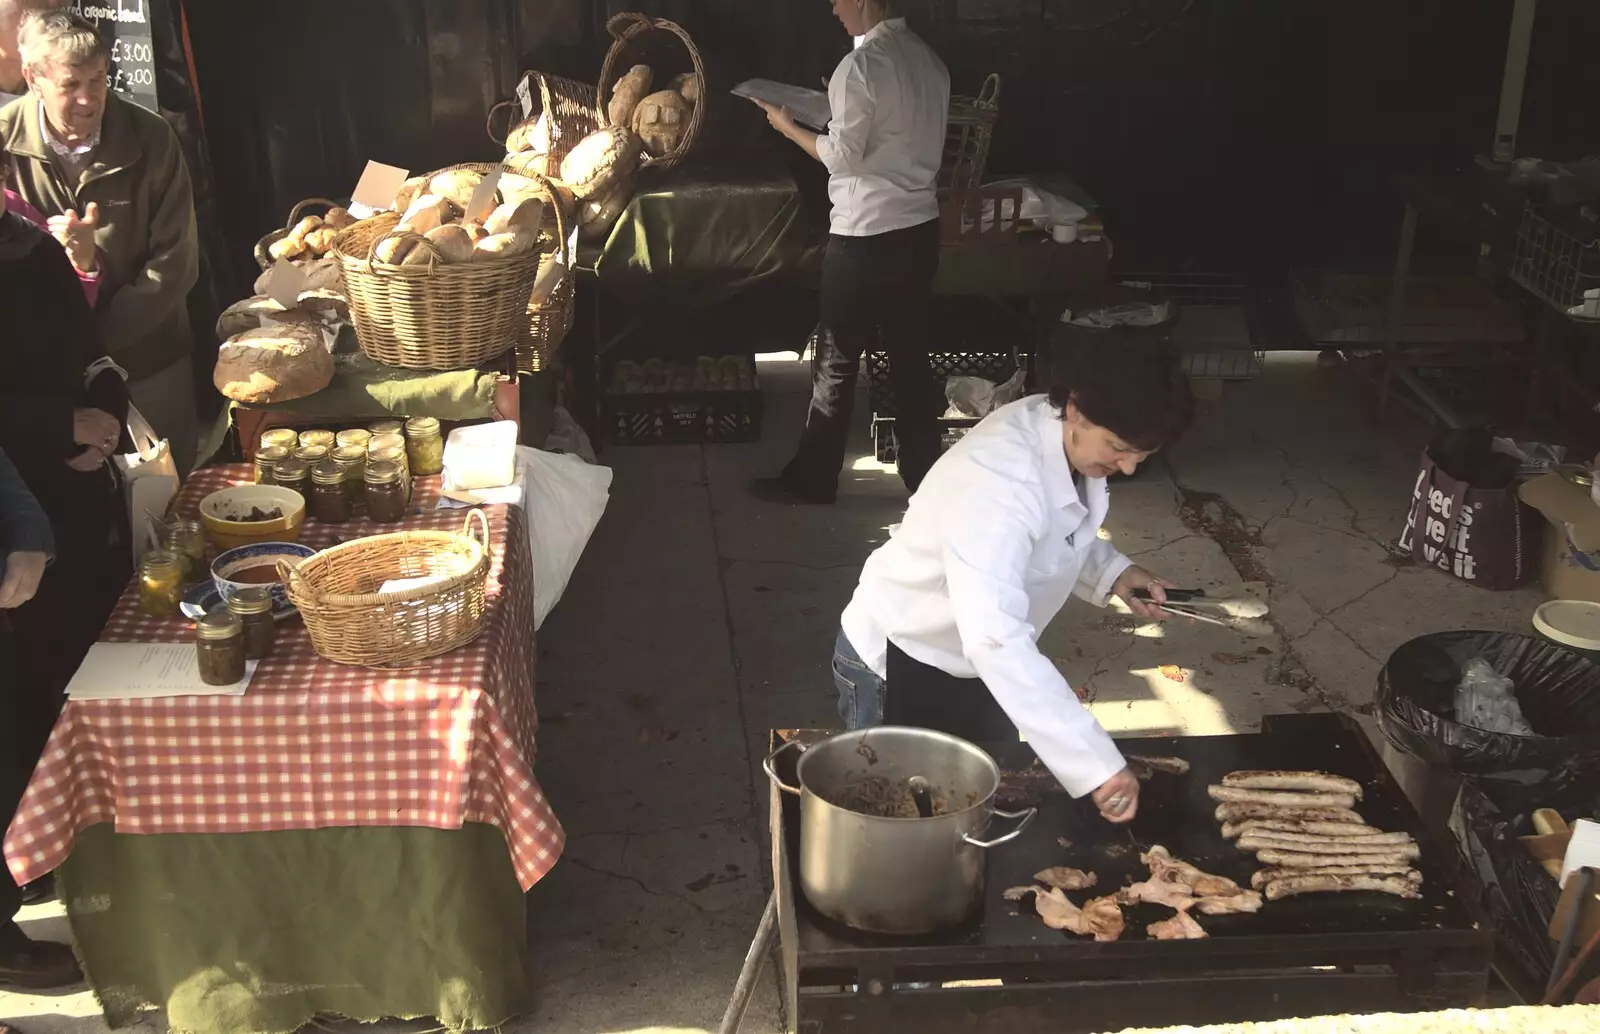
[834,340,1194,821]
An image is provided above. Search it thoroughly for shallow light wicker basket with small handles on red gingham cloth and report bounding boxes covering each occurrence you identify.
[278,509,490,667]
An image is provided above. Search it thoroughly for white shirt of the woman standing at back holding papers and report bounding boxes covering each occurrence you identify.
[816,18,950,237]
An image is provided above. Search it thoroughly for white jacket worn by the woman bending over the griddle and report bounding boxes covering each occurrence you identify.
[840,395,1130,797]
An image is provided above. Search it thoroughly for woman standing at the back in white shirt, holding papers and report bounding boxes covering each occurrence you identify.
[752,0,950,503]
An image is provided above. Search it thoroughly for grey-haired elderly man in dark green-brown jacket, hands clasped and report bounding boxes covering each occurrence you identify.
[0,11,200,472]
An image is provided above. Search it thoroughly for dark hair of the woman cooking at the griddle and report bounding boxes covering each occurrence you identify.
[1048,336,1195,451]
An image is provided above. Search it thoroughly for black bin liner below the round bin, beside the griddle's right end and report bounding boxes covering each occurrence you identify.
[1461,768,1600,989]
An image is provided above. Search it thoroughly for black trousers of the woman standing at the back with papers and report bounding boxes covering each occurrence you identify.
[784,219,944,496]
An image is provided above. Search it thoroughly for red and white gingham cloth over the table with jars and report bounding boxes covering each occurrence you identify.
[5,466,566,890]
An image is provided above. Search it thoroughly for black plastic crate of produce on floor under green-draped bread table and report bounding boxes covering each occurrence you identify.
[600,355,763,445]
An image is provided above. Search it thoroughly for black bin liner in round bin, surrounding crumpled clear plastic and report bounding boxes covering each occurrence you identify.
[1378,632,1600,776]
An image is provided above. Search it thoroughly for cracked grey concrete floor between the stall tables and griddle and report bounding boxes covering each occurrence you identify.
[0,355,1542,1034]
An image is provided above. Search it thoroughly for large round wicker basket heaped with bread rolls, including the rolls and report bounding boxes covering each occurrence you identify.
[333,163,560,370]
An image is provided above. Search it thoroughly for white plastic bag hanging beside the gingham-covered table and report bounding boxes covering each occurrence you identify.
[517,447,611,629]
